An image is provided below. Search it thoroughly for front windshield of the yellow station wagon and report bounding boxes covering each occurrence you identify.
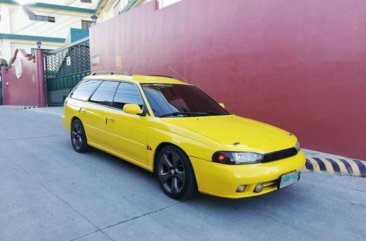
[141,84,230,117]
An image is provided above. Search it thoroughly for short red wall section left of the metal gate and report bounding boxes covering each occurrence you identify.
[2,50,45,107]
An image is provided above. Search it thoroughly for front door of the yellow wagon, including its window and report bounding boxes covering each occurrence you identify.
[103,82,148,166]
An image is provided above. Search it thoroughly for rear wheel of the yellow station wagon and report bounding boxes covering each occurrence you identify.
[71,119,89,153]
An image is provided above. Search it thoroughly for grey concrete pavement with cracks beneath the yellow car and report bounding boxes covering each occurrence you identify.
[0,107,366,241]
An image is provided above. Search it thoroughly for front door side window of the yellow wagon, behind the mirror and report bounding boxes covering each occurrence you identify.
[113,82,144,109]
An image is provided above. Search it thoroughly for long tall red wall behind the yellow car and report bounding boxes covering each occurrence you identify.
[91,0,366,159]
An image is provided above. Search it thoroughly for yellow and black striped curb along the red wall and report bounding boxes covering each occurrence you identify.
[305,157,366,177]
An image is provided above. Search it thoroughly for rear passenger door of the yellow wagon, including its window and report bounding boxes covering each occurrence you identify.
[85,80,119,150]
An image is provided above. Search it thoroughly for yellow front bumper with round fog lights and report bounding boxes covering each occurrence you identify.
[190,151,306,198]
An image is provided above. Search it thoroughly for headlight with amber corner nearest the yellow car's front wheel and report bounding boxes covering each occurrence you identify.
[212,151,263,165]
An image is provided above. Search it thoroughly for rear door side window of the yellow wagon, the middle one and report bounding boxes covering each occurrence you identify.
[90,81,119,105]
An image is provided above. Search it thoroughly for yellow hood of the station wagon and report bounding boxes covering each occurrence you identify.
[161,115,297,153]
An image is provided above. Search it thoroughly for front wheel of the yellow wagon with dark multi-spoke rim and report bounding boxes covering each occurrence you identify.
[155,146,197,199]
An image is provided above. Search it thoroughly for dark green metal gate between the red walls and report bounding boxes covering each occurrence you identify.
[45,39,90,106]
